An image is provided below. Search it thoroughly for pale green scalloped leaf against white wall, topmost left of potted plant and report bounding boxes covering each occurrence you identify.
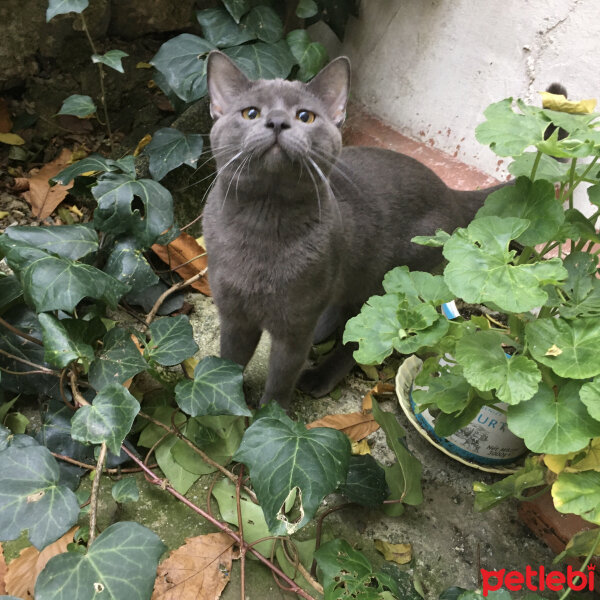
[475,98,548,157]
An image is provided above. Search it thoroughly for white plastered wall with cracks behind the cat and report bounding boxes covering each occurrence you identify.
[342,0,600,177]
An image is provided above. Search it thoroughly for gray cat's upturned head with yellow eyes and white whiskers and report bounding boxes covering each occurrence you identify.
[207,51,350,175]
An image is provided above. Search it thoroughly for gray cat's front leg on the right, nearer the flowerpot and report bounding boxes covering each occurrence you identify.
[260,329,313,410]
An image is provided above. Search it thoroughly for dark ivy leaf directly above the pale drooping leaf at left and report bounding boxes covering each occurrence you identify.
[88,327,148,391]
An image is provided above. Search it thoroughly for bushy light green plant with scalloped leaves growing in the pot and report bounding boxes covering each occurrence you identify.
[344,98,600,580]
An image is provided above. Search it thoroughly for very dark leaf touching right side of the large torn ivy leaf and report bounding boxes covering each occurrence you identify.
[340,454,390,507]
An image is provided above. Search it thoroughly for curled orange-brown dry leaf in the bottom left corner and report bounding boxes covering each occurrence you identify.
[4,526,77,600]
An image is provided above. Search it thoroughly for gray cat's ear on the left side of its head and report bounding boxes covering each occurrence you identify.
[206,50,250,119]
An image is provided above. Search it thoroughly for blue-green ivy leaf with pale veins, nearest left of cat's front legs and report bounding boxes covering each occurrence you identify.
[144,315,198,367]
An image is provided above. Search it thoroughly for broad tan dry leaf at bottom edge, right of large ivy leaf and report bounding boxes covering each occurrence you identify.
[152,533,238,600]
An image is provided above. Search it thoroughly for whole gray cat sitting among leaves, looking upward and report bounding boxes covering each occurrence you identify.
[203,52,500,408]
